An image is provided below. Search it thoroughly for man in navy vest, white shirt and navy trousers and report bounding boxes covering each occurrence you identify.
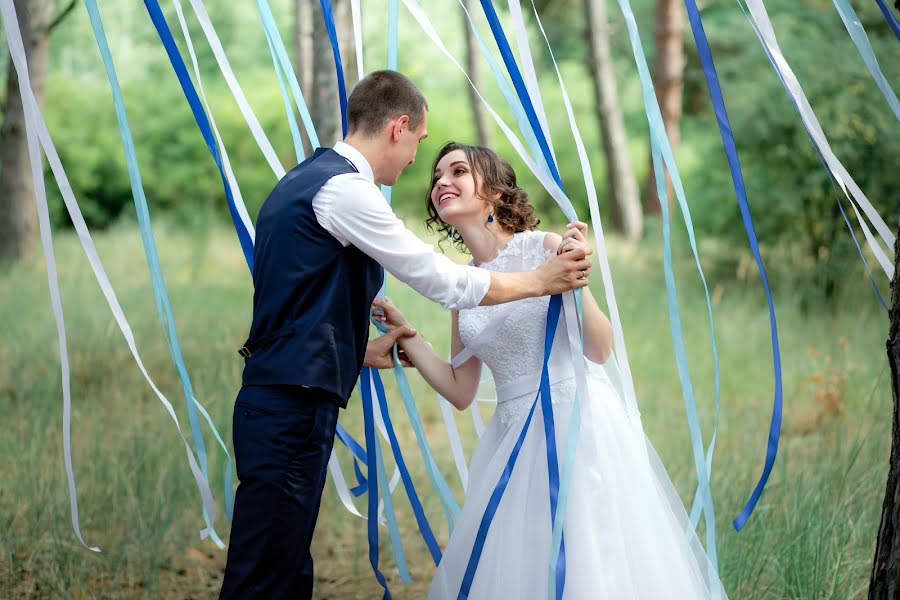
[220,71,591,598]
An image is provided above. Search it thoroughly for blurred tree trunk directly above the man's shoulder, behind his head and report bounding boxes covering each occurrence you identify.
[307,0,348,147]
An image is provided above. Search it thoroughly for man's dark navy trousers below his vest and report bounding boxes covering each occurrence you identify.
[219,386,339,599]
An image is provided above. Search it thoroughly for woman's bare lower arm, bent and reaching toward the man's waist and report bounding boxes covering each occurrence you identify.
[372,300,481,410]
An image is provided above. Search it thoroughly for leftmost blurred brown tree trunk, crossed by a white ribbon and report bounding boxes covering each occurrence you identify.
[0,0,50,262]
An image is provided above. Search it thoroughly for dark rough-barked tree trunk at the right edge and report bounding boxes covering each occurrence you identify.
[869,226,900,600]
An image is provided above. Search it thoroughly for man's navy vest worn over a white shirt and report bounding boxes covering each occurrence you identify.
[240,148,384,406]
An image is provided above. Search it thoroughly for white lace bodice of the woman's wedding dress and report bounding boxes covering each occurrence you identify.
[459,231,574,421]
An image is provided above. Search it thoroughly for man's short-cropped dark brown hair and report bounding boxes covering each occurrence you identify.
[347,70,428,136]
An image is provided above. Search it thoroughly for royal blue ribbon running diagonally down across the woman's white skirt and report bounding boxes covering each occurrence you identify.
[457,294,564,600]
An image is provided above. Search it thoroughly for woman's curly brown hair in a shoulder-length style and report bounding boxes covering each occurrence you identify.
[425,142,541,252]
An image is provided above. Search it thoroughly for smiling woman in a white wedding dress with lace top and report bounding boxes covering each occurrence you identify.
[373,142,725,600]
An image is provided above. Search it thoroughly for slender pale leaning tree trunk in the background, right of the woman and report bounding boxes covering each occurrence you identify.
[584,0,644,240]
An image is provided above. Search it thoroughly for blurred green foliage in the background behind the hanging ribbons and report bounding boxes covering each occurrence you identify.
[8,0,900,293]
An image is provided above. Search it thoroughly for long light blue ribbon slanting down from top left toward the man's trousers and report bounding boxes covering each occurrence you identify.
[84,0,234,545]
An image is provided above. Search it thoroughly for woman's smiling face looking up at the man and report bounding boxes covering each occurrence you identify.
[431,150,489,227]
